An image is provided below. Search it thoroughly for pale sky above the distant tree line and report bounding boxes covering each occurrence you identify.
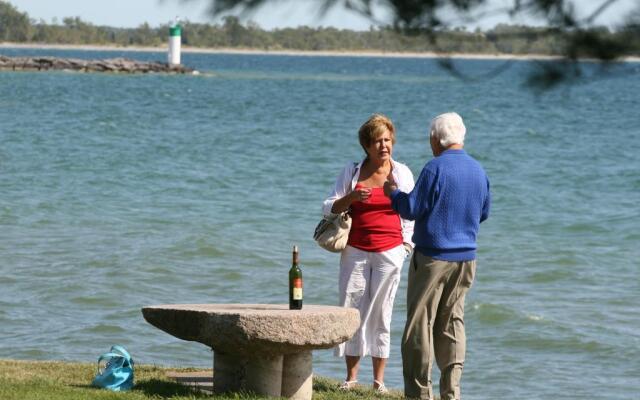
[4,0,639,30]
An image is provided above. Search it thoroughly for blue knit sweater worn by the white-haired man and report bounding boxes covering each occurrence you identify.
[391,150,491,261]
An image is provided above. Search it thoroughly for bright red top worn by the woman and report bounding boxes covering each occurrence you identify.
[347,183,402,253]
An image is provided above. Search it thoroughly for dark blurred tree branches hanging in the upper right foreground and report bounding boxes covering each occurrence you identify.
[189,0,640,88]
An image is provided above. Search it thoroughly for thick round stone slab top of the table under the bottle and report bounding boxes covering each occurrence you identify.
[142,304,360,354]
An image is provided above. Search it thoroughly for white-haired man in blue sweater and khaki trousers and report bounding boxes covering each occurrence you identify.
[384,113,491,400]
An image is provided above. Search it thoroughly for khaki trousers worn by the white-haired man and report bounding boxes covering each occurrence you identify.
[402,251,476,400]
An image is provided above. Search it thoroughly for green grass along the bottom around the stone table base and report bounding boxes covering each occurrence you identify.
[0,360,403,400]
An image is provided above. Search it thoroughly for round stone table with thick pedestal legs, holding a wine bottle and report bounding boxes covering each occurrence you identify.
[142,304,360,400]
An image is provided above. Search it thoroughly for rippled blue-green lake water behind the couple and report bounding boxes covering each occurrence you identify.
[0,49,640,399]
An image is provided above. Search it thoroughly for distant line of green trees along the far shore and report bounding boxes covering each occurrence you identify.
[0,0,640,59]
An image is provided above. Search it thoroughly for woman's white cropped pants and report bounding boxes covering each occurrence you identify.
[335,245,406,358]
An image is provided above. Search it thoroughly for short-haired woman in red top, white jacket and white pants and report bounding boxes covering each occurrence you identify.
[323,114,414,393]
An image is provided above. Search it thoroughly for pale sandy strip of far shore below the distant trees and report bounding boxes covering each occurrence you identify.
[5,42,640,62]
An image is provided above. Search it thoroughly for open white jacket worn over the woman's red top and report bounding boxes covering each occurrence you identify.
[322,159,414,247]
